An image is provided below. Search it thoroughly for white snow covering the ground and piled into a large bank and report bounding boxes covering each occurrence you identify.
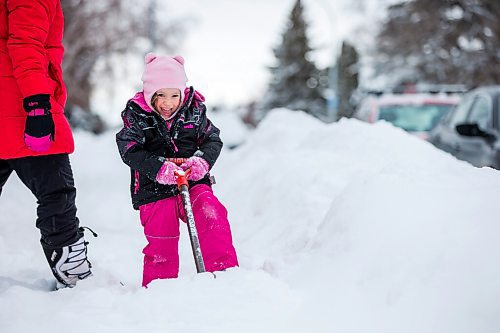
[0,109,500,333]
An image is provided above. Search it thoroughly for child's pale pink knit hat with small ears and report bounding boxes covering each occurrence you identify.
[141,53,187,109]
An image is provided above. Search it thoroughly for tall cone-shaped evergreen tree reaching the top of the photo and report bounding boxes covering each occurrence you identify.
[261,0,326,118]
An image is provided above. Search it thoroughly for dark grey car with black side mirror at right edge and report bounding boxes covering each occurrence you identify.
[429,86,500,169]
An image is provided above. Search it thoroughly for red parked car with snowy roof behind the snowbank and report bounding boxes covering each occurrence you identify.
[354,93,460,140]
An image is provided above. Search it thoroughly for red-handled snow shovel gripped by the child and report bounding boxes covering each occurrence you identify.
[167,158,206,273]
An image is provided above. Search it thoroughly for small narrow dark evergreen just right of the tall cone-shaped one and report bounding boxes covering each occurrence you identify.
[337,42,359,118]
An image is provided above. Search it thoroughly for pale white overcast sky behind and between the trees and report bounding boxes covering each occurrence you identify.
[93,0,394,124]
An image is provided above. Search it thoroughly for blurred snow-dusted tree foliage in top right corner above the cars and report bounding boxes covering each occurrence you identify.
[378,0,500,87]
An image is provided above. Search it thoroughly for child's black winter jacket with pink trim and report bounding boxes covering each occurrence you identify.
[116,87,222,209]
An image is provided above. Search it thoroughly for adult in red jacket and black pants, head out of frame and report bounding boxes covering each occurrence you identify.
[0,0,91,287]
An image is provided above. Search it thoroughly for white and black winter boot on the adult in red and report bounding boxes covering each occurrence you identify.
[44,236,92,289]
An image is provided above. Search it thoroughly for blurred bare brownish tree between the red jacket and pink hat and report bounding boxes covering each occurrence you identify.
[61,0,182,132]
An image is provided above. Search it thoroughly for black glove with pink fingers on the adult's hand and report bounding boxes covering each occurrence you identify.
[23,94,55,153]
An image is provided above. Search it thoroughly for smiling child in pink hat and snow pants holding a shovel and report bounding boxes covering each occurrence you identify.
[116,53,238,287]
